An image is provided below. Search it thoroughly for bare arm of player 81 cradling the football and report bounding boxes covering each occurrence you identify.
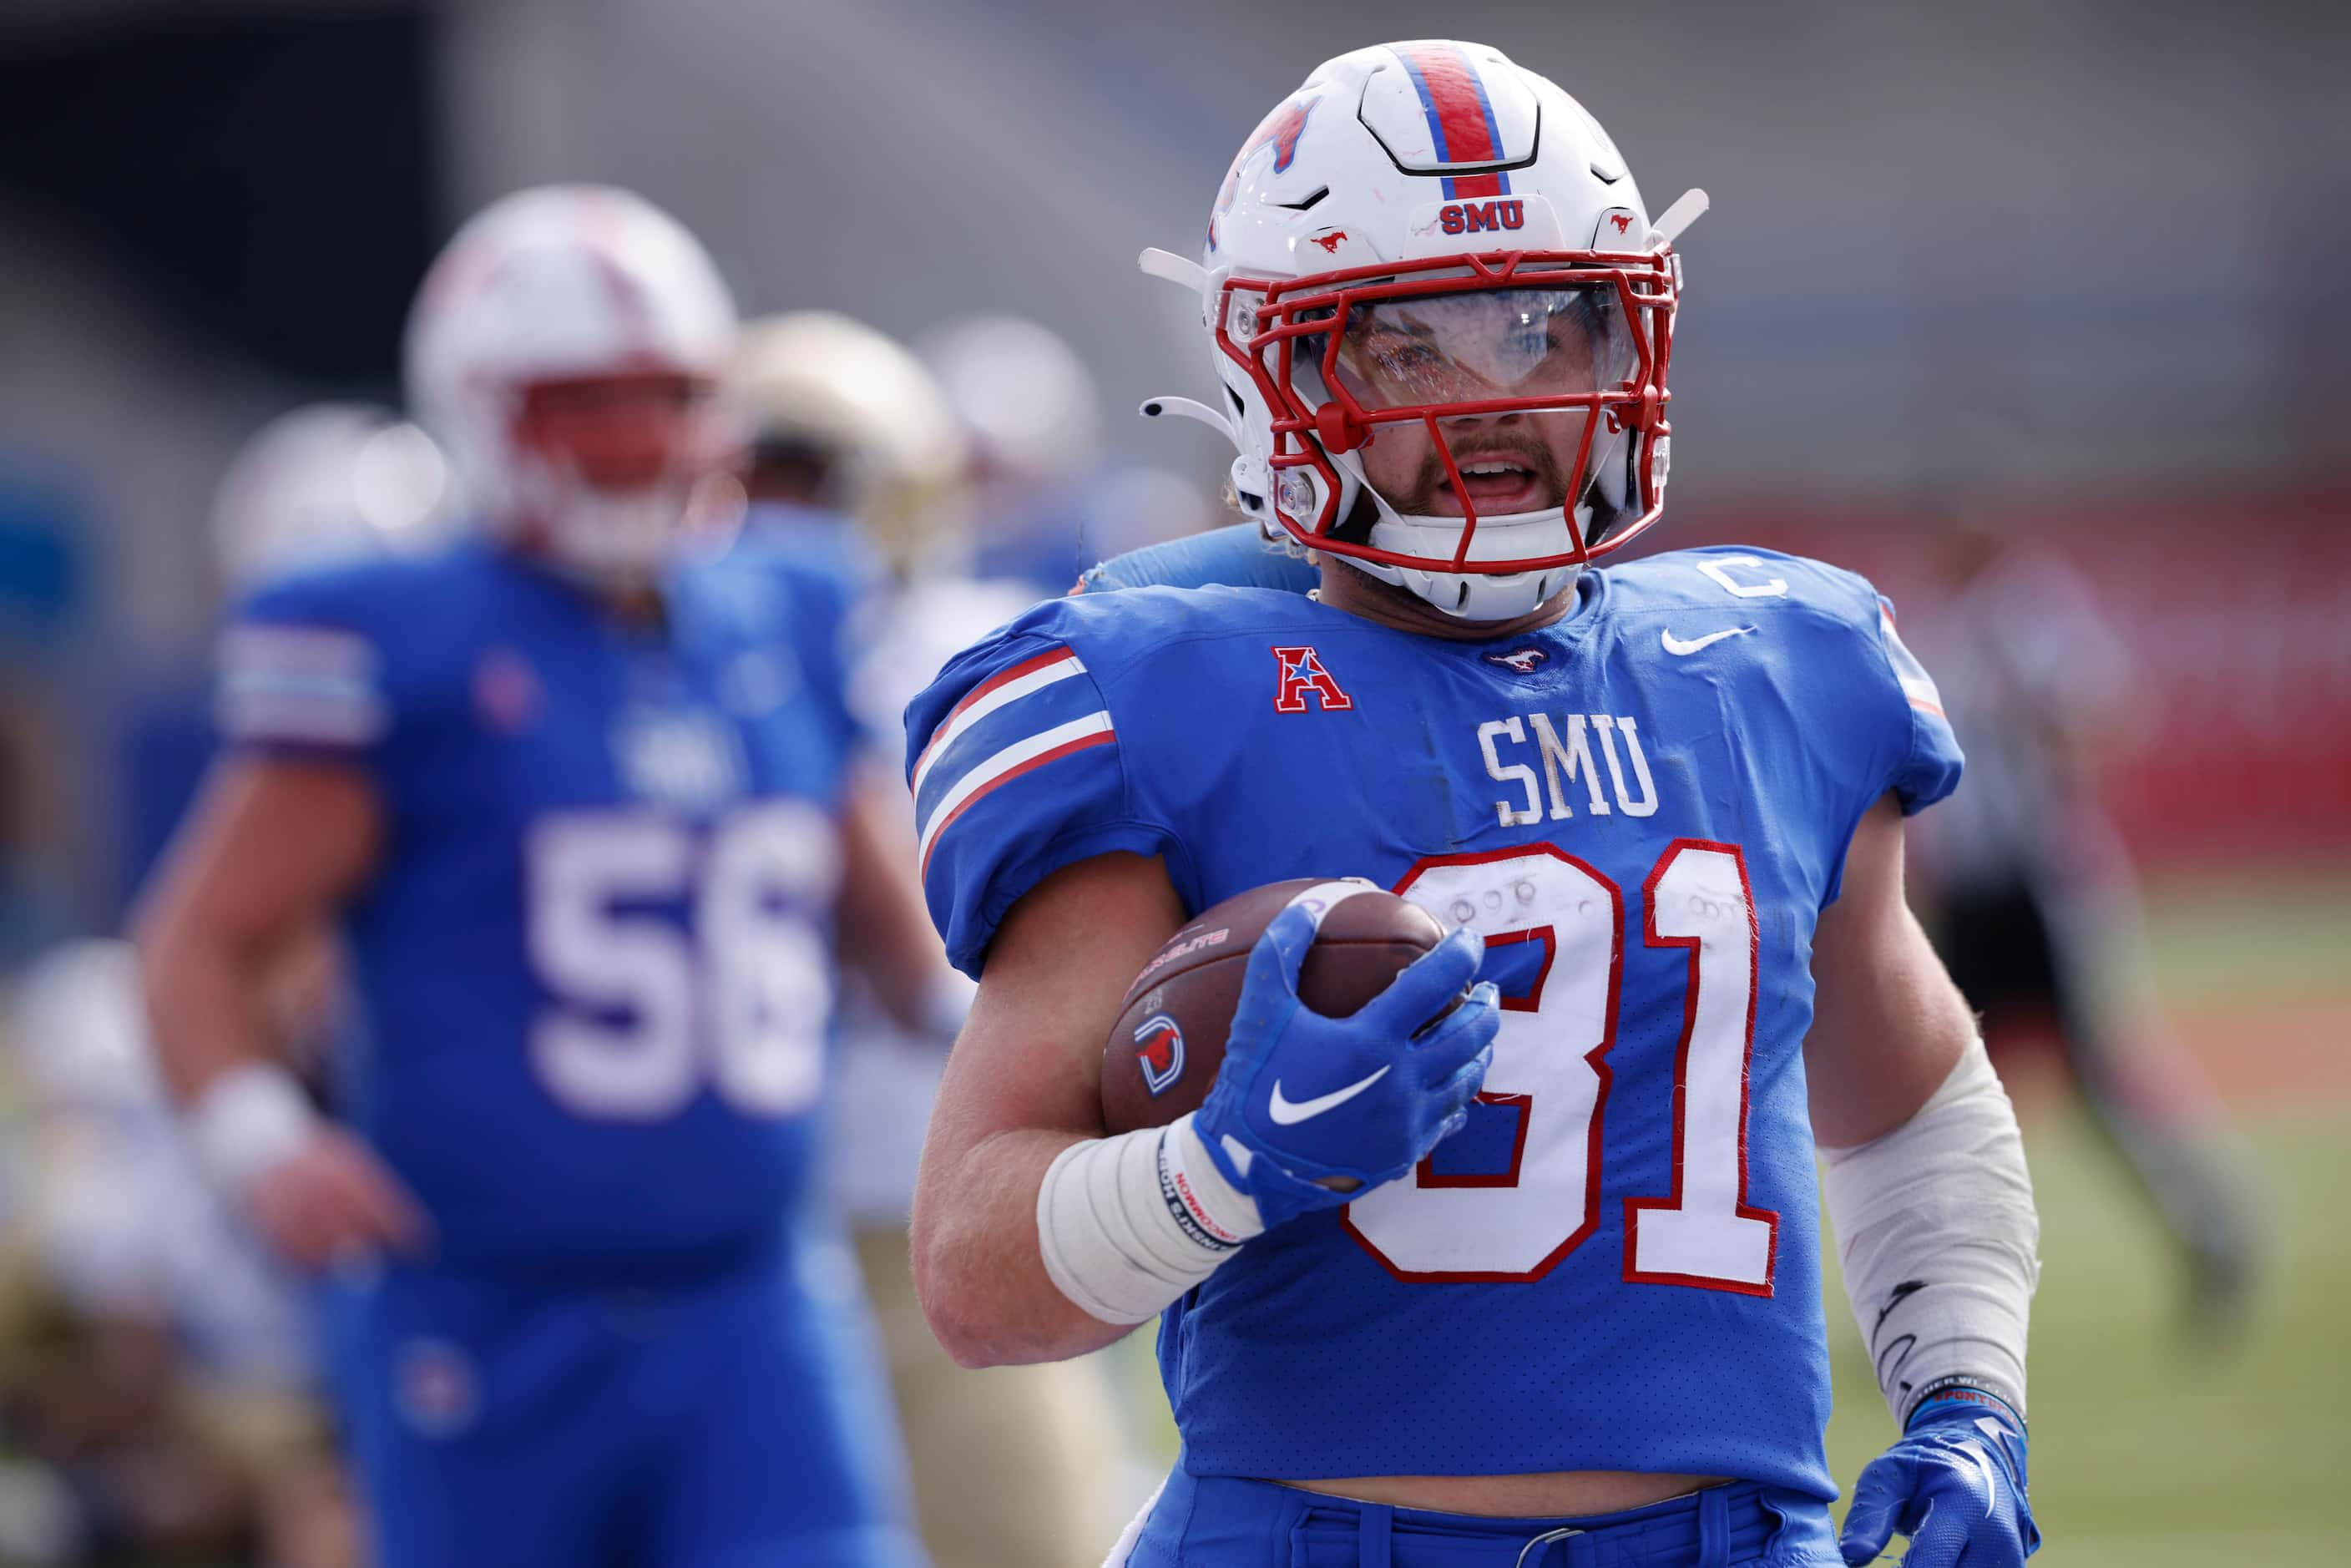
[914,856,1182,1366]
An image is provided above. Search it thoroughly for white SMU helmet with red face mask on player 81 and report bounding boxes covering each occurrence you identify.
[1143,40,1705,620]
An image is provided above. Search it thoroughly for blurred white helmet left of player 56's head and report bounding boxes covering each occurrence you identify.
[211,402,453,590]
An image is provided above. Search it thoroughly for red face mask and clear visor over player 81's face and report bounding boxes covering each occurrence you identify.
[1218,251,1679,574]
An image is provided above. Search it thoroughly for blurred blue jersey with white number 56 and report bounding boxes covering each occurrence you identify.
[219,543,853,1277]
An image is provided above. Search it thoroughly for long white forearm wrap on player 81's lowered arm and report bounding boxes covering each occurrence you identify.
[1820,1041,2040,1424]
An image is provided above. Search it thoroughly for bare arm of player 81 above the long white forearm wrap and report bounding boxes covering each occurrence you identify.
[1803,795,1974,1147]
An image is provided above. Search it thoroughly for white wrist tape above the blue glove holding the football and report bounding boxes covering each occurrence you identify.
[1037,1116,1265,1323]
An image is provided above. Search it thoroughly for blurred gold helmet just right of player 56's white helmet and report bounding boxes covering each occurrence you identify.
[729,311,971,574]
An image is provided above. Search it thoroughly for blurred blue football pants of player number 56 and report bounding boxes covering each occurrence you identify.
[326,1243,922,1568]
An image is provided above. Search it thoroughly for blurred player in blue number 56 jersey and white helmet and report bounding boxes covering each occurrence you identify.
[141,188,943,1568]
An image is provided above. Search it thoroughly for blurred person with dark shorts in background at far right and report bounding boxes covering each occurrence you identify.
[1914,510,2262,1333]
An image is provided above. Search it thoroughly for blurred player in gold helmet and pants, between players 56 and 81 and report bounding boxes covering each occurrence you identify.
[731,311,1124,1568]
